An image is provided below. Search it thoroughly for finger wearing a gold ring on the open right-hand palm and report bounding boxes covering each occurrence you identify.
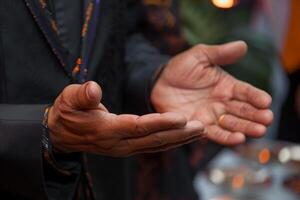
[219,115,267,137]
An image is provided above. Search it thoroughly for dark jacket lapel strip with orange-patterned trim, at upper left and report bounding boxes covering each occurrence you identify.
[24,0,72,76]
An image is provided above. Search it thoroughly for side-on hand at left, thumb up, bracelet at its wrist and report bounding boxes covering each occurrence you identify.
[48,81,204,157]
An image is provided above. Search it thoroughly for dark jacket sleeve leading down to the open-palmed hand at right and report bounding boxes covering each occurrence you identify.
[125,0,169,114]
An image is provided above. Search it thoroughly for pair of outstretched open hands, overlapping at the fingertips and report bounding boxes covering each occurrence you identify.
[48,41,273,157]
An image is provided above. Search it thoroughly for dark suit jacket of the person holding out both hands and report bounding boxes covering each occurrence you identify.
[0,0,202,200]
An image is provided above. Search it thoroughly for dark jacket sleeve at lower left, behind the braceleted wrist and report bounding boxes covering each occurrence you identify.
[0,104,80,200]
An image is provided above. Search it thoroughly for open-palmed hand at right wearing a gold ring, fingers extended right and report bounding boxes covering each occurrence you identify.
[151,41,273,145]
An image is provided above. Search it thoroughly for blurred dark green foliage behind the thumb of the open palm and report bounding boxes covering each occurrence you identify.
[179,0,277,93]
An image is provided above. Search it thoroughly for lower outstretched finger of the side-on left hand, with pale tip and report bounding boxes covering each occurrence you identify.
[124,121,203,152]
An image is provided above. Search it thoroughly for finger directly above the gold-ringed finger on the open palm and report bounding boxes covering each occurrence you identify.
[226,100,274,126]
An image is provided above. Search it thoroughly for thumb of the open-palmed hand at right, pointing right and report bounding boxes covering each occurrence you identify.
[196,41,247,65]
